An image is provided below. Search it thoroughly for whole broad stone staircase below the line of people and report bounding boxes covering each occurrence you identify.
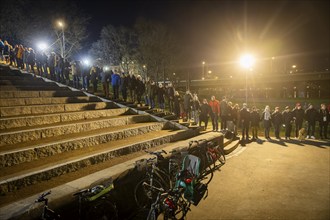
[0,65,197,196]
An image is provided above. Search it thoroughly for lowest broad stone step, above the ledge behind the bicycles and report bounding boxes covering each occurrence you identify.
[0,130,188,194]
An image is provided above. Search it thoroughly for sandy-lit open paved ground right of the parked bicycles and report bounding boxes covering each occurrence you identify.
[188,140,330,220]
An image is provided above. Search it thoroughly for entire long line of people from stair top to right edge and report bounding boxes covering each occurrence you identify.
[0,39,330,140]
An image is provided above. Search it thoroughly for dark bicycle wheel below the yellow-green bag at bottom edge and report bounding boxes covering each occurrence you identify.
[85,199,118,220]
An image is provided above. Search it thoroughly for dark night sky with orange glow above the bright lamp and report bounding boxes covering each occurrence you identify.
[77,0,330,72]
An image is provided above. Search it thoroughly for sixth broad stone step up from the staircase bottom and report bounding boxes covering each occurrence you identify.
[0,96,101,107]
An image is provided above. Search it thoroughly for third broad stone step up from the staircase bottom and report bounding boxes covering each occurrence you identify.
[0,115,151,147]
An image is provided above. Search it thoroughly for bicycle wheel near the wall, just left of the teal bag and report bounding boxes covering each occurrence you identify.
[134,178,164,208]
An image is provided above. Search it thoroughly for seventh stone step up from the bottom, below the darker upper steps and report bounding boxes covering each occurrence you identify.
[0,90,86,99]
